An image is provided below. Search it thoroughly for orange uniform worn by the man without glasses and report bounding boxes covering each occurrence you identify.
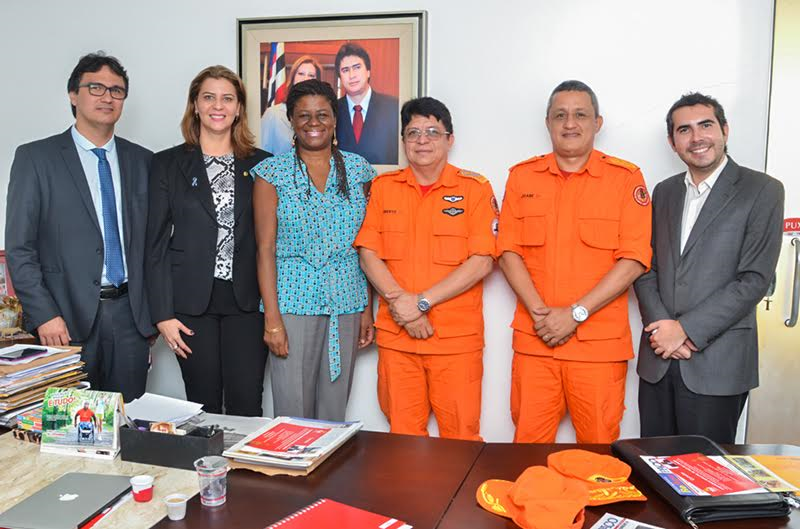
[497,150,651,443]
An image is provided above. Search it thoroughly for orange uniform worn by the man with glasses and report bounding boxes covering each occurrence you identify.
[354,164,497,440]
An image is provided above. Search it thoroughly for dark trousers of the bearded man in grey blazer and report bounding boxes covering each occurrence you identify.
[639,353,747,444]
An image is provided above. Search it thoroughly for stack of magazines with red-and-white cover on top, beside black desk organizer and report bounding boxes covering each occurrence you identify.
[222,417,362,475]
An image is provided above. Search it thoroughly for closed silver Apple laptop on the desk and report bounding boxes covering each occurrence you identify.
[0,472,131,529]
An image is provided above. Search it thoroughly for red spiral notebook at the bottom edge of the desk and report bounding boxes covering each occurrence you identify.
[266,498,411,529]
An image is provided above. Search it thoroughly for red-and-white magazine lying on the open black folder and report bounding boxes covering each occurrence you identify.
[641,453,766,496]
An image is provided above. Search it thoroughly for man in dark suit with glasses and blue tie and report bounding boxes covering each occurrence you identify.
[6,53,155,401]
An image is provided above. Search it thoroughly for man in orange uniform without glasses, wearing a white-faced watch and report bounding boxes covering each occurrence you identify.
[497,81,651,443]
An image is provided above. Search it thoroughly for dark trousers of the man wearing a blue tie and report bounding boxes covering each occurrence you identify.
[77,294,150,402]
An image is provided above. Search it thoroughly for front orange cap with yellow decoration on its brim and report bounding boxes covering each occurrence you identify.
[475,467,589,529]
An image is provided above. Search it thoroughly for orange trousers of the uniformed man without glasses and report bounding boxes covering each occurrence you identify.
[511,352,628,444]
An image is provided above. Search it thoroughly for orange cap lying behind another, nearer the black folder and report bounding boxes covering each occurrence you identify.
[547,449,647,506]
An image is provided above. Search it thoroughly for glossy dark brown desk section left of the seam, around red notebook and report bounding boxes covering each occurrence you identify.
[155,431,484,529]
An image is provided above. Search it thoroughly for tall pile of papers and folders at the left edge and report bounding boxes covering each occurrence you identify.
[0,344,87,427]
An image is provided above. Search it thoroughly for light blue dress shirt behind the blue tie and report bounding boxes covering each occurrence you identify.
[70,125,128,286]
